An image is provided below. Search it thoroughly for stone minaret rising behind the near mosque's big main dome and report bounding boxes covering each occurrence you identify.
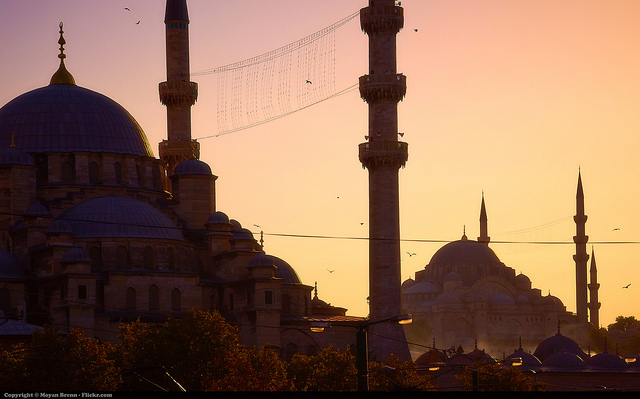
[159,0,200,176]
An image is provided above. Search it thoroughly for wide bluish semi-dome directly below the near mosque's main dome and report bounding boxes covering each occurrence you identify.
[58,195,184,241]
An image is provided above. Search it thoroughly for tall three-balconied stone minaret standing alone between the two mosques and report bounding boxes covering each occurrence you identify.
[359,0,411,360]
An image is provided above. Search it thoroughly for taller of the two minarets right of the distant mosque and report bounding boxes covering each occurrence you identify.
[573,172,589,322]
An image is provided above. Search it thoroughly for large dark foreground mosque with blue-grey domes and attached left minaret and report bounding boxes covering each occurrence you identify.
[0,0,363,355]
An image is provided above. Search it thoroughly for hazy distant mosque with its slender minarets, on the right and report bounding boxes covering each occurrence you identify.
[402,174,600,358]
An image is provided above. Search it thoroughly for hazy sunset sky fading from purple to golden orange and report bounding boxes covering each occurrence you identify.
[0,0,640,326]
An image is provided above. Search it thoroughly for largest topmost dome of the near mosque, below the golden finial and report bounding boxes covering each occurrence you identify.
[0,84,153,157]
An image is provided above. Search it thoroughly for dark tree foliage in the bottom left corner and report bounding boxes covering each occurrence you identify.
[0,326,121,392]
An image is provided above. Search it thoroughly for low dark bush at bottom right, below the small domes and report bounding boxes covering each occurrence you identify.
[456,363,546,391]
